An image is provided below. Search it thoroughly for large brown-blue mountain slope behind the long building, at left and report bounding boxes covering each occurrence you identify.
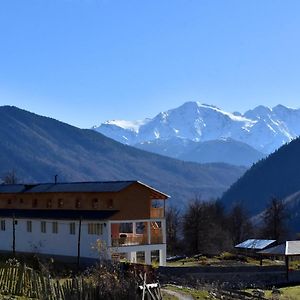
[0,106,245,207]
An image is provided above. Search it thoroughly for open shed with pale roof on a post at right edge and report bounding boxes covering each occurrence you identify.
[258,241,300,279]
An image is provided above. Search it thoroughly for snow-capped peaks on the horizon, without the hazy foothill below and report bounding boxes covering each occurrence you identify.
[94,102,300,154]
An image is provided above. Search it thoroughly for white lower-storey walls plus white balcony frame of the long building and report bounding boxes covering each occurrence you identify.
[0,218,166,265]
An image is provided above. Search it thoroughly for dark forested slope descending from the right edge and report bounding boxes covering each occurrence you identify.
[221,138,300,215]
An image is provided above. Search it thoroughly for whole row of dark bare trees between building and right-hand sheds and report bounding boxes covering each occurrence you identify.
[166,198,289,255]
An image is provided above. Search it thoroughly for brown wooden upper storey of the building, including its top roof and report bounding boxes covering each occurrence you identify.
[0,181,168,220]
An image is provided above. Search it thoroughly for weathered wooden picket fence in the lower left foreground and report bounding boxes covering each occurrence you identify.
[0,263,162,300]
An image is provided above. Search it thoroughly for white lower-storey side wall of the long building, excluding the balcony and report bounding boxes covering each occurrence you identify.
[0,219,108,258]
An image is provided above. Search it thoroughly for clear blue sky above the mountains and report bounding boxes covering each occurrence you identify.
[0,0,300,127]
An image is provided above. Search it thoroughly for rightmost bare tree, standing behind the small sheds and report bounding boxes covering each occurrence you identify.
[261,198,288,242]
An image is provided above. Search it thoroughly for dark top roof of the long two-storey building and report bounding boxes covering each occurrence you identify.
[0,180,169,199]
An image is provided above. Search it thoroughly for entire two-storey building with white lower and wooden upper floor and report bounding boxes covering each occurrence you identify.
[0,181,168,266]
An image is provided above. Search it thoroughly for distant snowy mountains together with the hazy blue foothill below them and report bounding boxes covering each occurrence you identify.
[93,102,300,166]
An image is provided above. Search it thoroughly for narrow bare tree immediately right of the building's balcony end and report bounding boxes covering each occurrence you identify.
[166,206,181,254]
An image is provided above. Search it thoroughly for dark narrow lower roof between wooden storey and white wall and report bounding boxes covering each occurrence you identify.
[0,209,118,220]
